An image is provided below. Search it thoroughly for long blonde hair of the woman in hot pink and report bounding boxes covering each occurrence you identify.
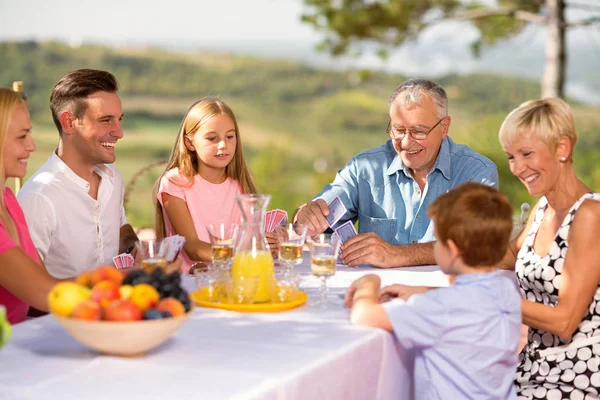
[0,88,25,244]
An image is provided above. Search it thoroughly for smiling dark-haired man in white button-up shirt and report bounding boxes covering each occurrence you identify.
[18,69,137,279]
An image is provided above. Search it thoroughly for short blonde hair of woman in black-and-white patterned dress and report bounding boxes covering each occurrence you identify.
[498,97,577,162]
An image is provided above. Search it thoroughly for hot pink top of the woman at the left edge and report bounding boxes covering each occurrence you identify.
[0,187,40,324]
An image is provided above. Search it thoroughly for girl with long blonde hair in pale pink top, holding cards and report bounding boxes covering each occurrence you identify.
[154,97,277,271]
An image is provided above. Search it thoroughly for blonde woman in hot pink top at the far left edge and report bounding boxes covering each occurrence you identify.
[0,88,57,324]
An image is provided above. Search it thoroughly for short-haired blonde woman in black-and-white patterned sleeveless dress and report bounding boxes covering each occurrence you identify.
[499,98,600,399]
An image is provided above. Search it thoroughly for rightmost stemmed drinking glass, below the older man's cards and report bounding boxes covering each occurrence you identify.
[309,233,342,306]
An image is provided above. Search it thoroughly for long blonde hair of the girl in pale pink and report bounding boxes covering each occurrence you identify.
[152,97,256,239]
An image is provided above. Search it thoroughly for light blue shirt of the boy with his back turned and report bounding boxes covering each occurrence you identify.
[383,271,521,400]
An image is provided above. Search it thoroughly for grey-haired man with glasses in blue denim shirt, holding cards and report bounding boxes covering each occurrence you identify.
[294,79,498,268]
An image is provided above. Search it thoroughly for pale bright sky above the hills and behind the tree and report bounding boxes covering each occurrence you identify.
[0,0,600,105]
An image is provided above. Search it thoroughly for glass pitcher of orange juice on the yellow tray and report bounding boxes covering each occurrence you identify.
[231,194,274,303]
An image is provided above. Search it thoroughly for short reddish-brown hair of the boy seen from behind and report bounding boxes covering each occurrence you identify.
[427,182,513,267]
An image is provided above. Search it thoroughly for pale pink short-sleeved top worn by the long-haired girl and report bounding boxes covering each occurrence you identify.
[158,168,242,272]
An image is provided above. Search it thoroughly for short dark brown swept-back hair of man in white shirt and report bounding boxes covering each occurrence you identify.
[50,69,119,135]
